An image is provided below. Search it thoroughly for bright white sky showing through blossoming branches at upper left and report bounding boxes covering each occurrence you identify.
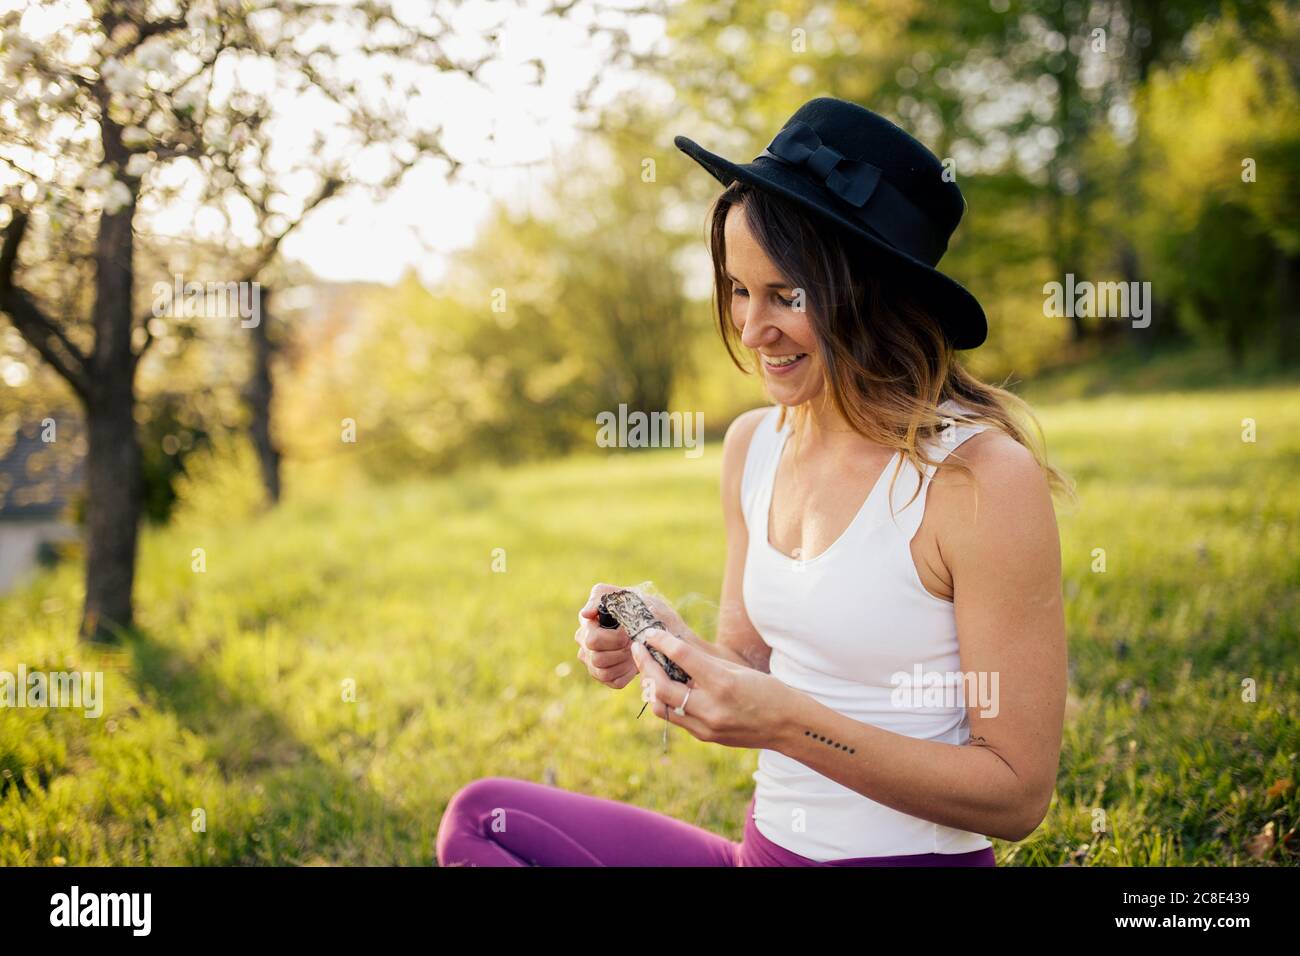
[0,0,672,284]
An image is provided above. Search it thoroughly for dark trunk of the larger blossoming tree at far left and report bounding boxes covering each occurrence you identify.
[81,198,144,641]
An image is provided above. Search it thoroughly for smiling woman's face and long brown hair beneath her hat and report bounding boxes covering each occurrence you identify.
[710,172,1069,509]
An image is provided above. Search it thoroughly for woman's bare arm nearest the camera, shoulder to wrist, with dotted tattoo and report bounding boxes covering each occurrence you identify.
[771,432,1066,840]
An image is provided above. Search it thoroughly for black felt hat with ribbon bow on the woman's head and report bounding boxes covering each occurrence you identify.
[672,96,988,349]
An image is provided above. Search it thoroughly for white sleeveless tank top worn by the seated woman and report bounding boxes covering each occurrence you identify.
[741,402,991,862]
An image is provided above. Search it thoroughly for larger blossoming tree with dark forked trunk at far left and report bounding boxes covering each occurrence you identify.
[0,0,644,640]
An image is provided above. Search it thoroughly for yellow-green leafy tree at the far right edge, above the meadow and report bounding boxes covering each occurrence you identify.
[1134,4,1300,359]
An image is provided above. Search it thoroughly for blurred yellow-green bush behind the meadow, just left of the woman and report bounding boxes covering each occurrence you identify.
[290,106,698,477]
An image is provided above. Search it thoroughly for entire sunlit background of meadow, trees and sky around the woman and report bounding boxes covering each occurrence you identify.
[0,0,1300,865]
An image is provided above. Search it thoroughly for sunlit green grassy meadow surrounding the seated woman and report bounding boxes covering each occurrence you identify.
[0,374,1300,865]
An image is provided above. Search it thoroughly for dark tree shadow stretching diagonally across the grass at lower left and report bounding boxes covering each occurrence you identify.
[120,630,434,865]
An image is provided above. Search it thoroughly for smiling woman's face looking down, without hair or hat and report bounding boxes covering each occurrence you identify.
[724,206,822,405]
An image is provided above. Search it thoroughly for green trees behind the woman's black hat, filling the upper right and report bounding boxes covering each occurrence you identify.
[668,0,1300,369]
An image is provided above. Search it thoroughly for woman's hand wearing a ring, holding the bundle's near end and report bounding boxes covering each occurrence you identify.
[632,627,793,749]
